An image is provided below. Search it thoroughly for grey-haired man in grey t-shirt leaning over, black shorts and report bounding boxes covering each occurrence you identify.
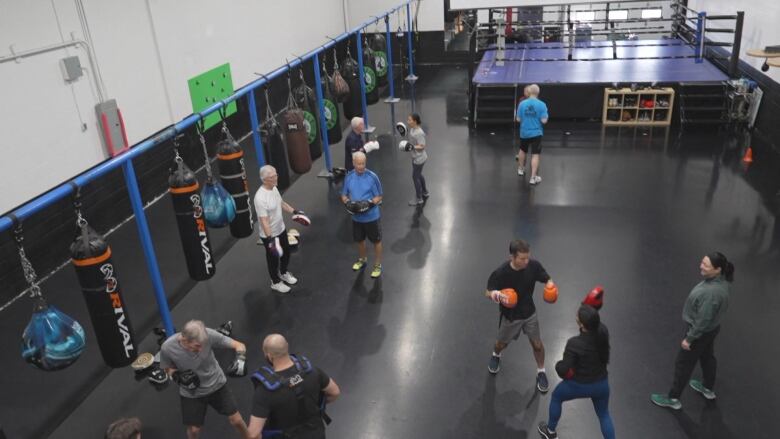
[160,320,249,439]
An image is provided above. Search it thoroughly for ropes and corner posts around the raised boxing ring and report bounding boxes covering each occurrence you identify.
[475,0,744,77]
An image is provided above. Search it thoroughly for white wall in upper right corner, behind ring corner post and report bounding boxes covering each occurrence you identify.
[688,0,780,82]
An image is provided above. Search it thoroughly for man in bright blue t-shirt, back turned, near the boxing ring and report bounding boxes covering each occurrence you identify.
[515,84,549,185]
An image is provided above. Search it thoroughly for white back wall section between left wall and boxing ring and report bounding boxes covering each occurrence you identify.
[345,0,444,32]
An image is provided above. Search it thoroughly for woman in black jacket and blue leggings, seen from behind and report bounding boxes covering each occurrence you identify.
[539,305,615,439]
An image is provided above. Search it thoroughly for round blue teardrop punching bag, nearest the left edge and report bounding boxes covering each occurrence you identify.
[22,296,86,371]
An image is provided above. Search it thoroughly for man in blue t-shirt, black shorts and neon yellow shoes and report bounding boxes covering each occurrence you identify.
[341,151,382,279]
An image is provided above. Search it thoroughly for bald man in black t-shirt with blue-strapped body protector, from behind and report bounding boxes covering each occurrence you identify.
[249,334,340,439]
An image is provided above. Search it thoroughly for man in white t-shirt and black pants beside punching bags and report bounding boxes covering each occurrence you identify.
[254,165,298,293]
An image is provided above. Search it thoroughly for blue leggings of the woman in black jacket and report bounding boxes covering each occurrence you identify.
[547,378,615,439]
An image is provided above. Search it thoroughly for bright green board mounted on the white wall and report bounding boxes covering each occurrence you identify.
[187,63,236,129]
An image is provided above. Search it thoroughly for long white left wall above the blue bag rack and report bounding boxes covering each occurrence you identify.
[0,0,348,212]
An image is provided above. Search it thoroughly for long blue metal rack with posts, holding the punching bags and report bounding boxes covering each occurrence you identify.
[0,0,419,334]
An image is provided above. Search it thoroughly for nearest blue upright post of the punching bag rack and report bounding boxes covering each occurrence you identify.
[122,159,176,336]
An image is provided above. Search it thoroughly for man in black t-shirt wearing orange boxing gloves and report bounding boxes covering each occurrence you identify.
[485,239,554,393]
